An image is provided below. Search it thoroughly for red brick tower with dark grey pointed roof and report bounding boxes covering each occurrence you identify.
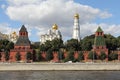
[9,25,33,62]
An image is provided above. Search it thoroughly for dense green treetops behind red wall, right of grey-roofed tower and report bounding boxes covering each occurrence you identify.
[33,34,120,51]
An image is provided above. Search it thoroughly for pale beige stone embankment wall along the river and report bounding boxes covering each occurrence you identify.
[0,63,120,71]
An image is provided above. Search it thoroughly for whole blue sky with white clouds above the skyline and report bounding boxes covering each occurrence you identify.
[0,0,120,42]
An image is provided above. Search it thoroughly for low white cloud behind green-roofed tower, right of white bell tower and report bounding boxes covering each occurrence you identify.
[81,23,120,38]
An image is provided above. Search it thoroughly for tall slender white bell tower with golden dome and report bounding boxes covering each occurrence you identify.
[72,13,80,41]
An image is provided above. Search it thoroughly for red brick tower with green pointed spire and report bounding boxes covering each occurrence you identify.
[92,26,108,60]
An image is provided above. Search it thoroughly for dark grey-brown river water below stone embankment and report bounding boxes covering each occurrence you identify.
[0,71,120,80]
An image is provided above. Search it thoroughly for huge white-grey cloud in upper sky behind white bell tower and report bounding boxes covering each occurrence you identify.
[6,0,112,41]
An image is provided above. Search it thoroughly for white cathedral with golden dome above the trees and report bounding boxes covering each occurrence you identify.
[40,24,62,43]
